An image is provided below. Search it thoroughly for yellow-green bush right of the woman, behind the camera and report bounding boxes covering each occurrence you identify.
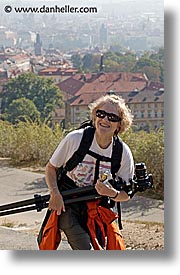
[122,129,164,197]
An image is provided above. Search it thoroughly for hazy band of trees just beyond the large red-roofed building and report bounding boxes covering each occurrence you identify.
[72,47,164,82]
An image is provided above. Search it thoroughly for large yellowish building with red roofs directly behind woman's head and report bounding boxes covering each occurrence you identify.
[58,72,164,129]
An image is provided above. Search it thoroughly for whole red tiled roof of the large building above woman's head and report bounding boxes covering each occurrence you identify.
[59,72,164,106]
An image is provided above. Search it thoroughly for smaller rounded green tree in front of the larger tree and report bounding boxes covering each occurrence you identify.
[4,98,40,124]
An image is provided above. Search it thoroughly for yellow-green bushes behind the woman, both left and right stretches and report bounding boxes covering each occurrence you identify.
[0,120,164,197]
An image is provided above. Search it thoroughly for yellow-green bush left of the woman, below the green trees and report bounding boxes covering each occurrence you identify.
[0,121,63,165]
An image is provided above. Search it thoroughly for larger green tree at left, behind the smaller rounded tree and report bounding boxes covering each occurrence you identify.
[1,73,63,120]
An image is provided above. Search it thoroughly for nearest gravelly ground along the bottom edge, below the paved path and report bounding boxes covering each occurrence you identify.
[0,221,164,250]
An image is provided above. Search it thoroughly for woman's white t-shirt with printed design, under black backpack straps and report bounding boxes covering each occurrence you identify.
[50,129,134,187]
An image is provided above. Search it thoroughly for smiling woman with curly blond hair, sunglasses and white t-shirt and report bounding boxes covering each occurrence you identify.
[46,95,134,250]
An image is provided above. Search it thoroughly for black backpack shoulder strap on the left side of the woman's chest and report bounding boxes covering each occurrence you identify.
[63,126,95,172]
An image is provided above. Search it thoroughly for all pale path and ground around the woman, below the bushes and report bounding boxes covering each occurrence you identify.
[0,167,164,250]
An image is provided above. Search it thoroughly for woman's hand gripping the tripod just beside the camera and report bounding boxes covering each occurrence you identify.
[95,180,117,197]
